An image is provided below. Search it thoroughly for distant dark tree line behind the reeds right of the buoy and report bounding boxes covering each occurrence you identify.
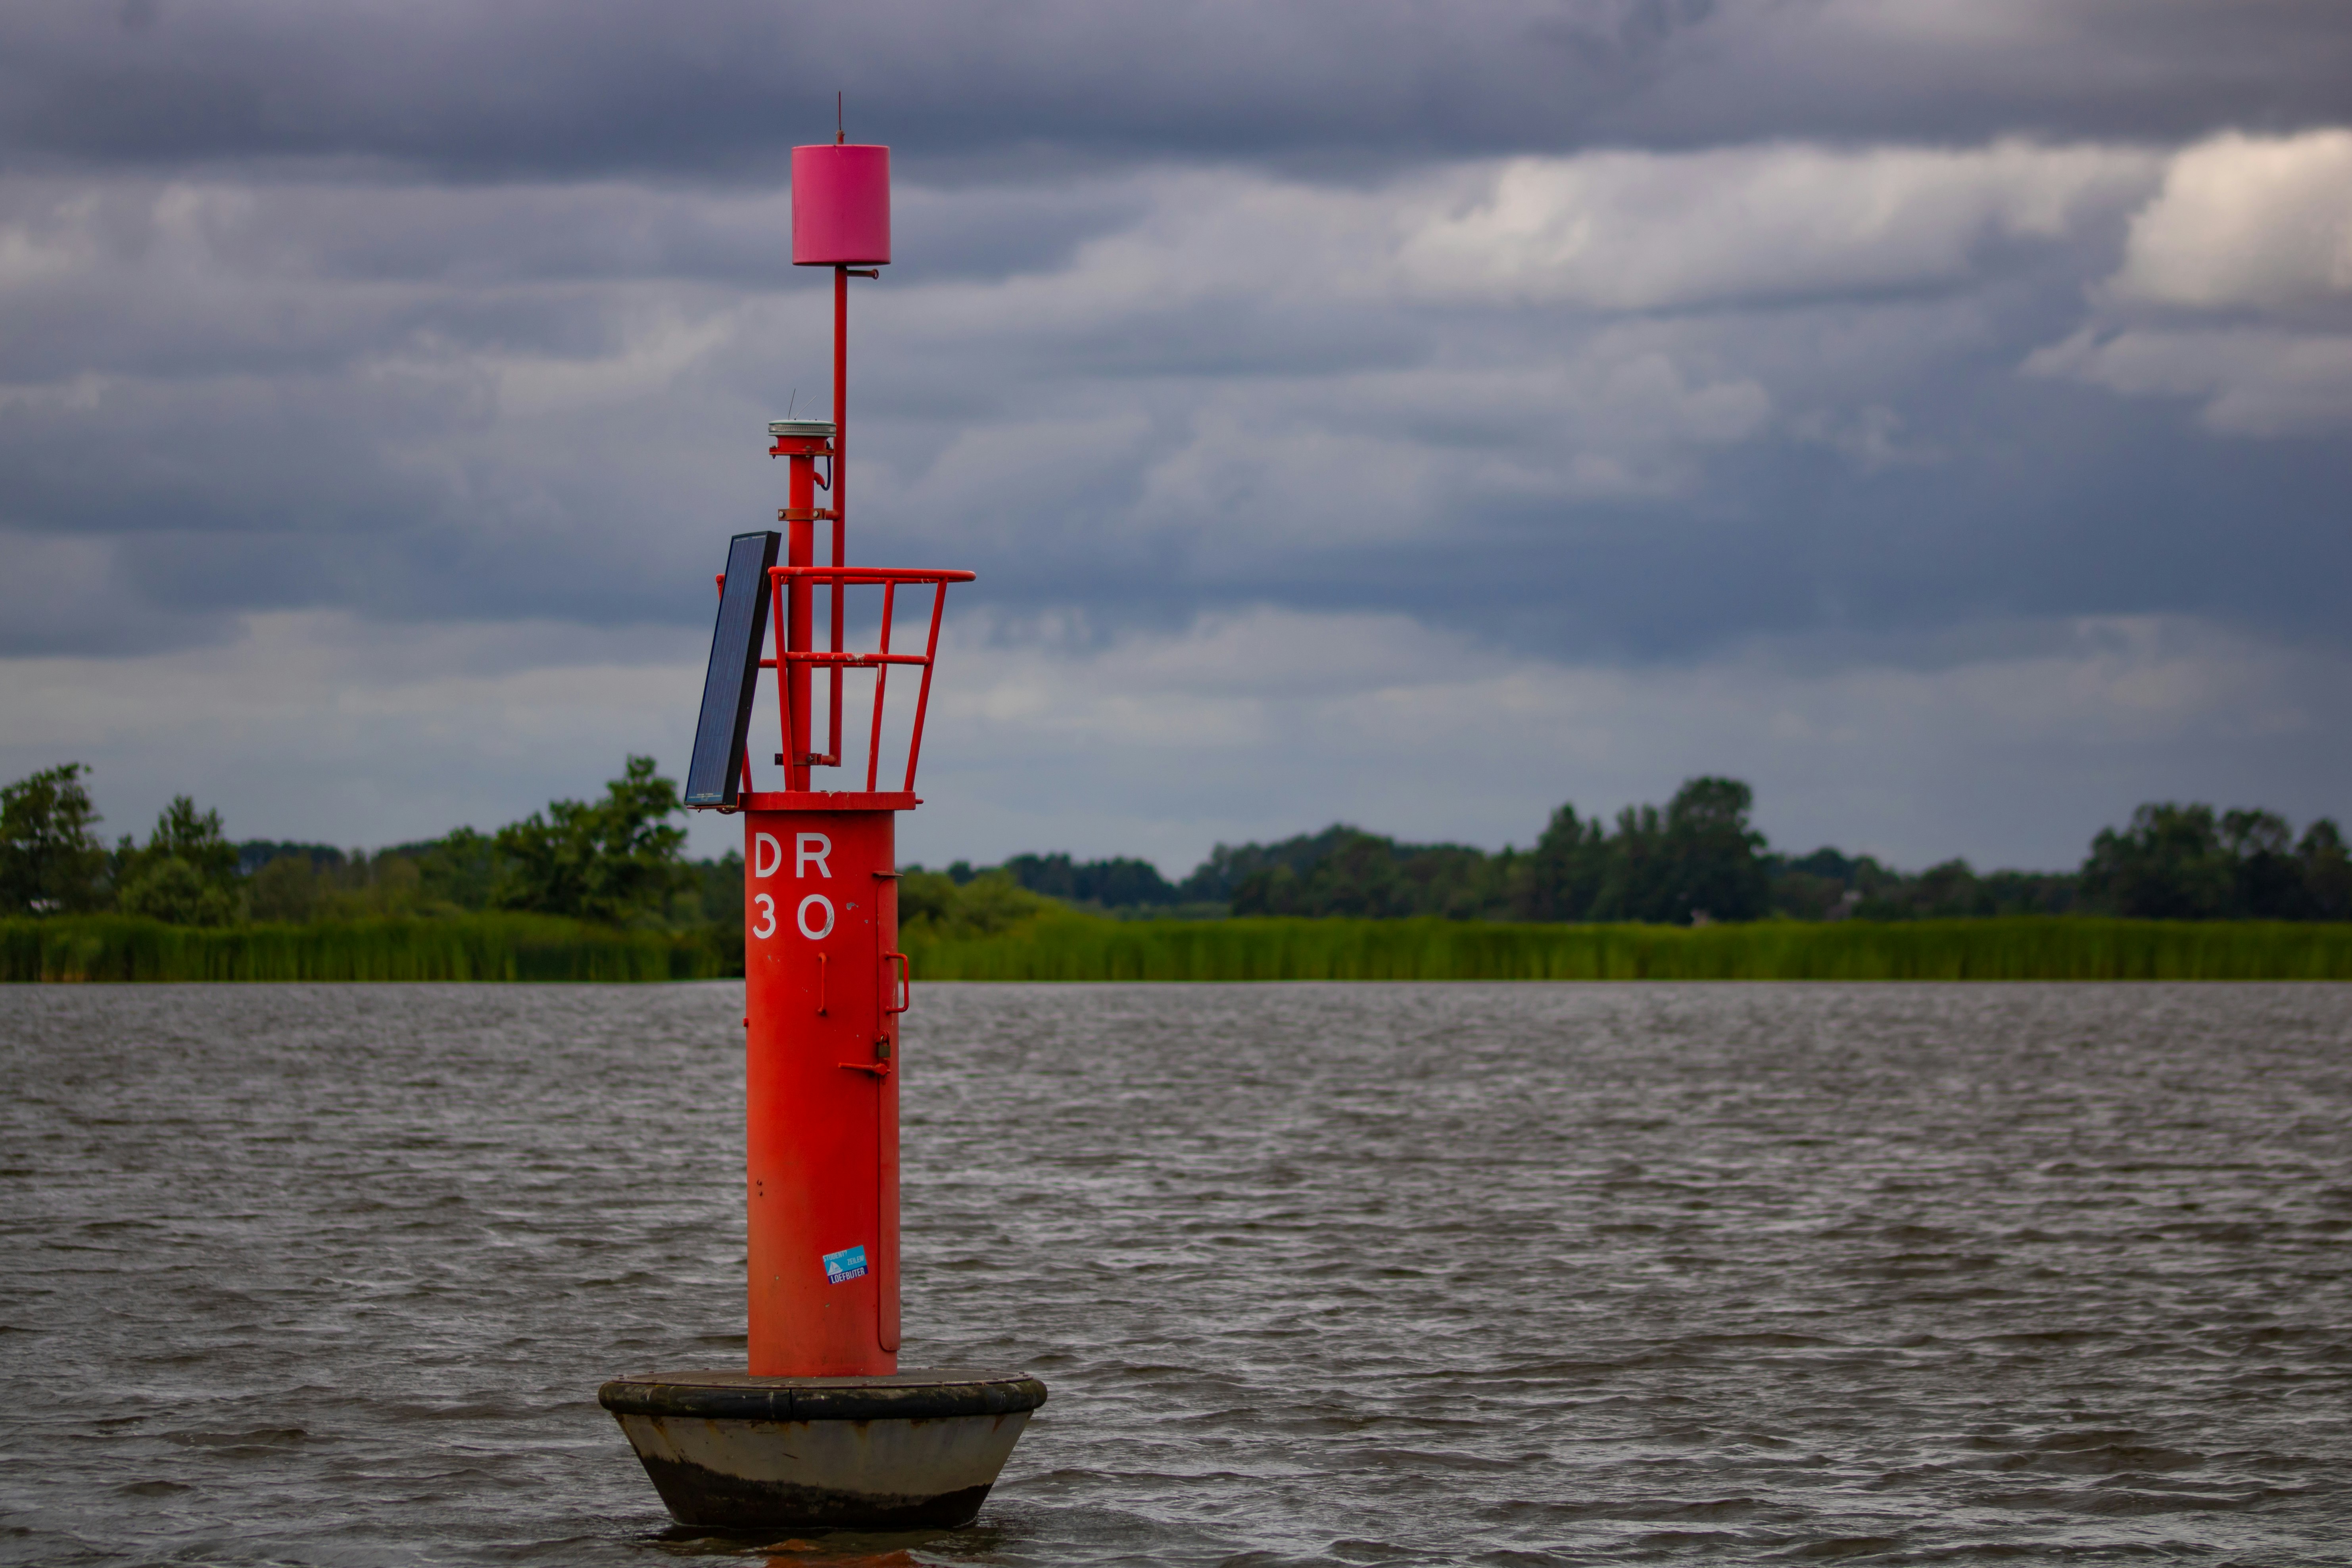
[917,778,2352,926]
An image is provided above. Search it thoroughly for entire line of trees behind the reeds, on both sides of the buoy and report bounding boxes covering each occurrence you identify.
[0,757,2352,936]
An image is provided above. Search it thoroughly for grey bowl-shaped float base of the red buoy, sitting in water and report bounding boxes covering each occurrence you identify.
[597,1370,1044,1530]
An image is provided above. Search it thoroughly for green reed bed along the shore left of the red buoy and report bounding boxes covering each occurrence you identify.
[0,914,743,980]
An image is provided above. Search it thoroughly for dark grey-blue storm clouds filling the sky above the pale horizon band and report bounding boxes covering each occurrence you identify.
[0,0,2352,701]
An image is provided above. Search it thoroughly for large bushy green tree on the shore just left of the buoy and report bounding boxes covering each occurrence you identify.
[492,757,691,924]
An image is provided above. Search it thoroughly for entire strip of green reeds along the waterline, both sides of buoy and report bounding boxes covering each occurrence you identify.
[0,914,2352,983]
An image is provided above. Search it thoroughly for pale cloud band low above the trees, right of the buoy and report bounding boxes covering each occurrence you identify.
[908,606,2352,872]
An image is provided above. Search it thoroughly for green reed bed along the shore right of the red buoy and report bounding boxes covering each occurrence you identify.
[901,914,2352,980]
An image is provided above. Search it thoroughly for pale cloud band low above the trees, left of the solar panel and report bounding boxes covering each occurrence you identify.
[0,611,701,846]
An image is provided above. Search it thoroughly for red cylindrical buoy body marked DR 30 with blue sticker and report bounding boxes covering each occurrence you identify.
[743,811,906,1378]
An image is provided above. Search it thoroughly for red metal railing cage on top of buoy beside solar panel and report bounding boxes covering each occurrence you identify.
[722,566,976,795]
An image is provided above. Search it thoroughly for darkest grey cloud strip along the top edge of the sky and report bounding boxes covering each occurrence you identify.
[0,0,2352,178]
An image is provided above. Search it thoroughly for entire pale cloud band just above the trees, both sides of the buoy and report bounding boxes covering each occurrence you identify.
[0,602,2352,872]
